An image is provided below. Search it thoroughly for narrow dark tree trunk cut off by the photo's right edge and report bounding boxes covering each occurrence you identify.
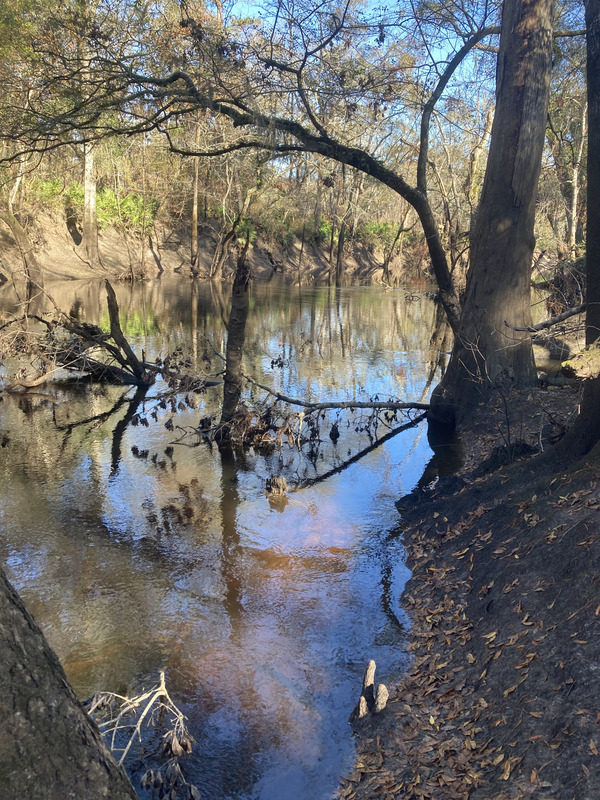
[553,0,600,456]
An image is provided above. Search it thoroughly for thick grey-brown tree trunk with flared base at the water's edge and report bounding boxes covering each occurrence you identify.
[431,0,554,424]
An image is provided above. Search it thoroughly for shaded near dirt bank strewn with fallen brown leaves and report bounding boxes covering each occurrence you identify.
[340,388,600,800]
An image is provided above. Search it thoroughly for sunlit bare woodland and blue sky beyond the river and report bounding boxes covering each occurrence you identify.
[0,0,587,294]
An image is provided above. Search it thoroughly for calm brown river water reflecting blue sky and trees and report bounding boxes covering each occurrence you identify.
[0,278,437,800]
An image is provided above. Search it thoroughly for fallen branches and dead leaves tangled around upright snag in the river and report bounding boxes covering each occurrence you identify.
[0,276,428,476]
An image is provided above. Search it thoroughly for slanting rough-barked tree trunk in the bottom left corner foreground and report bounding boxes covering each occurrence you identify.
[0,568,136,800]
